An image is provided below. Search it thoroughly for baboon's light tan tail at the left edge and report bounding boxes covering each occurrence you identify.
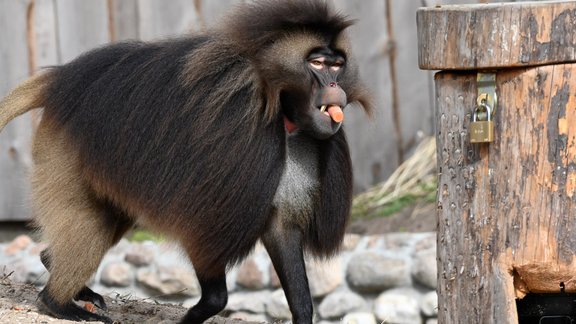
[0,72,52,131]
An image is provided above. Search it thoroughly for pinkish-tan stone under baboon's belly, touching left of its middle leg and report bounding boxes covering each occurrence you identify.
[137,266,200,296]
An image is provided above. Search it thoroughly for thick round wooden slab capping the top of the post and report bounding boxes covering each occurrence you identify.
[417,1,576,70]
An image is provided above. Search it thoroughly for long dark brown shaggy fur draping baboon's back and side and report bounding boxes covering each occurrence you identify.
[45,37,284,269]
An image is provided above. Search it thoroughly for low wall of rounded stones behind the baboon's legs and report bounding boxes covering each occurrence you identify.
[0,233,438,324]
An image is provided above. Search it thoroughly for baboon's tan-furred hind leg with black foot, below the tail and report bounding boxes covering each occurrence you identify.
[32,120,131,323]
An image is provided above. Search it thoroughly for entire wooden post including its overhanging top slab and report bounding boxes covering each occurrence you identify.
[417,2,576,323]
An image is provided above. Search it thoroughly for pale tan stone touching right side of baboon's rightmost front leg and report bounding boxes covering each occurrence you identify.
[306,257,344,298]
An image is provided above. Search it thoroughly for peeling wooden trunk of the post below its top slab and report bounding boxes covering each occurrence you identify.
[436,64,576,323]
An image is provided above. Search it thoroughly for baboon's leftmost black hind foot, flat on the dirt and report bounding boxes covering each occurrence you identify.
[38,289,113,324]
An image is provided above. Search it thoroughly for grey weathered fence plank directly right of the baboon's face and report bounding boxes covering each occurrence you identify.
[335,0,398,191]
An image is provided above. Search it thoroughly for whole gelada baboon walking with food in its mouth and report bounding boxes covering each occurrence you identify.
[0,0,370,323]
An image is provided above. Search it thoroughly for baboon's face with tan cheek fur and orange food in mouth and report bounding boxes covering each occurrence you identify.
[258,32,358,140]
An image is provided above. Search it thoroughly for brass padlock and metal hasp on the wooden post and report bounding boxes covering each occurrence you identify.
[470,73,498,143]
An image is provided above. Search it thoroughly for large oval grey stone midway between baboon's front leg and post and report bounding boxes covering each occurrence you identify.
[346,252,411,293]
